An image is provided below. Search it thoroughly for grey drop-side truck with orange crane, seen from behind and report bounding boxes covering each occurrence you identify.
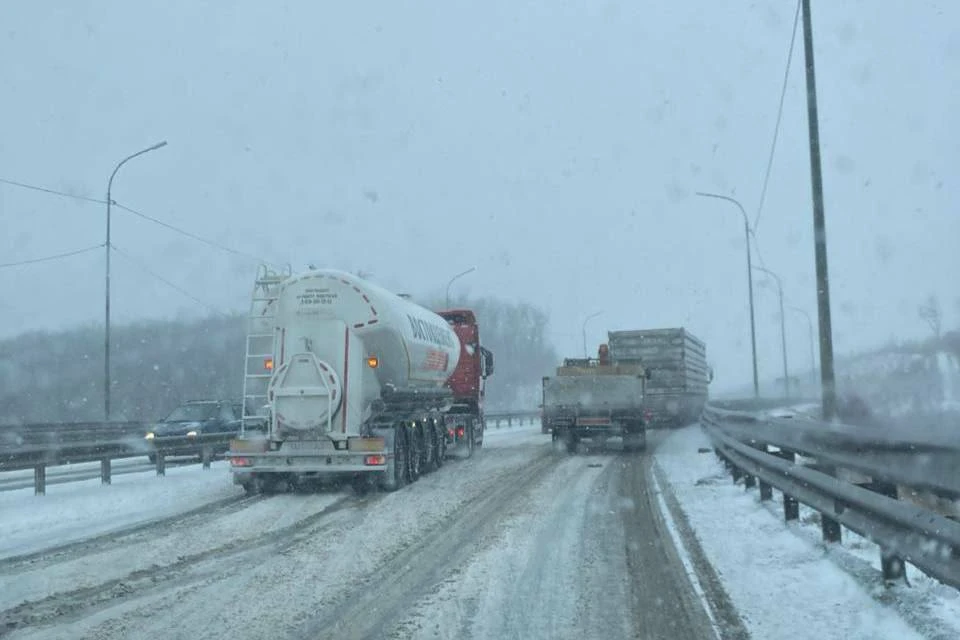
[541,345,647,453]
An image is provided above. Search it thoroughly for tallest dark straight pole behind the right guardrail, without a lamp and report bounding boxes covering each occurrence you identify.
[801,0,837,421]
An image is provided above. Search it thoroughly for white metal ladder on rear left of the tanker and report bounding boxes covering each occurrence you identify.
[240,265,290,434]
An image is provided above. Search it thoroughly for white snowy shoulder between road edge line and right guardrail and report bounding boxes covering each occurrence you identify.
[656,426,960,640]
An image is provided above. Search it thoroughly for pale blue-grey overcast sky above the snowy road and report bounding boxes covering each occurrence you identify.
[0,0,960,386]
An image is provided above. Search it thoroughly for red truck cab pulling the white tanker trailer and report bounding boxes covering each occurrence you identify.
[436,309,493,453]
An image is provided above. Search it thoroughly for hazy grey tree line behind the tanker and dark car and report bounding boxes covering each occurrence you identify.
[0,298,556,424]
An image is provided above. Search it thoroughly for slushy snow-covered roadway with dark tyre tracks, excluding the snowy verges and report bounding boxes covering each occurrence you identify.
[0,428,735,639]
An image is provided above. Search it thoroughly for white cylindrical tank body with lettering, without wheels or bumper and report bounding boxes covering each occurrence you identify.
[269,269,460,438]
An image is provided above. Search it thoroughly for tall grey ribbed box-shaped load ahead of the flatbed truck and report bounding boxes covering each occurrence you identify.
[607,327,713,428]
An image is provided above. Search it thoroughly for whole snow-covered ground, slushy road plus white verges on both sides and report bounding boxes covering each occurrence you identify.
[0,427,956,640]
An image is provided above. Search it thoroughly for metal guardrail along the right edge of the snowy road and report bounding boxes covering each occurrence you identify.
[701,403,960,588]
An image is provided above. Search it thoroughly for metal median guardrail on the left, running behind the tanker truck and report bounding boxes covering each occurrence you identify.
[0,410,540,495]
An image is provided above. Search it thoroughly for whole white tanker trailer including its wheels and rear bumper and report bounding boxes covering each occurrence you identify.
[228,269,461,492]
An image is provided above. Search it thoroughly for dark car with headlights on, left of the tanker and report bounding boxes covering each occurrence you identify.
[145,400,242,462]
